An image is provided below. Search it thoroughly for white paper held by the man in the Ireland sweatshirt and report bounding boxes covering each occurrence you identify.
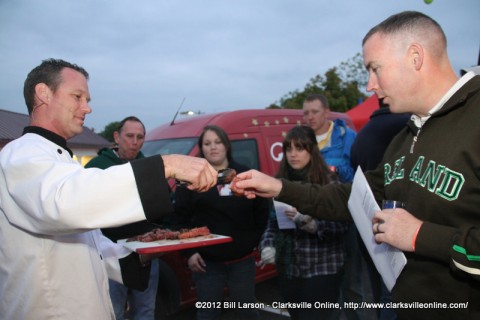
[348,167,407,291]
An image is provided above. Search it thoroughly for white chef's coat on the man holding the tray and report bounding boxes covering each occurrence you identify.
[0,133,172,320]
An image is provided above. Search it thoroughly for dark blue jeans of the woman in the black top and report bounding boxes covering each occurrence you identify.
[192,257,259,320]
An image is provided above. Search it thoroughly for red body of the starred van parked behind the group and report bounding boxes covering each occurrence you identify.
[145,109,354,311]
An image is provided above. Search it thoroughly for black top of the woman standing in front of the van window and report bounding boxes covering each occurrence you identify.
[174,162,270,261]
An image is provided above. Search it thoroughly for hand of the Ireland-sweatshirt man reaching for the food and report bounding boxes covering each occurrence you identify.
[230,170,282,199]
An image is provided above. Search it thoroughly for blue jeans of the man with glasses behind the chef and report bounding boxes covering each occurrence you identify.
[109,259,159,320]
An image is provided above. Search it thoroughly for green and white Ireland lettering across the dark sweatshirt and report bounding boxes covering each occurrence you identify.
[384,156,465,201]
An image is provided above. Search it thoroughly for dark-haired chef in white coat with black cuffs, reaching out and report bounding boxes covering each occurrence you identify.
[0,59,216,320]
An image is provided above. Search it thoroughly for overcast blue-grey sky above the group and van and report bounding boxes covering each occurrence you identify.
[0,0,480,132]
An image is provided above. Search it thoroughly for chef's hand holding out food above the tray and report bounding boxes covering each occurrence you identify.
[162,154,217,192]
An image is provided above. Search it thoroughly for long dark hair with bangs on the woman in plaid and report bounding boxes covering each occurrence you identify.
[276,125,331,185]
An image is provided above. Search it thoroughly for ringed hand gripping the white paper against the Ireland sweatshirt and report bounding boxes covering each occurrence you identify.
[372,208,423,252]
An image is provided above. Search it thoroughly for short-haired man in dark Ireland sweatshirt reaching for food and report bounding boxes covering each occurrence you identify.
[232,11,480,319]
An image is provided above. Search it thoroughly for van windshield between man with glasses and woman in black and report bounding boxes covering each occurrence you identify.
[142,138,197,157]
